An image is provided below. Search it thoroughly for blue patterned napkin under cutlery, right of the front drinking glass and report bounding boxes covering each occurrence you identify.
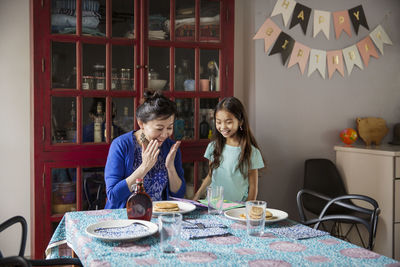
[181,219,231,239]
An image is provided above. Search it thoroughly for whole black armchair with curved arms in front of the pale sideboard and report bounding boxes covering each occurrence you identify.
[297,159,380,249]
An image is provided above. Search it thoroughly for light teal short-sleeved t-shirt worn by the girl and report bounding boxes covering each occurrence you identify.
[204,142,264,201]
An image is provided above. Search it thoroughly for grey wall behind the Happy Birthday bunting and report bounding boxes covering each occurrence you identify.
[248,0,400,218]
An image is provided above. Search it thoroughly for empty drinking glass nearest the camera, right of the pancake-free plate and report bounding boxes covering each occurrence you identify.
[158,213,182,253]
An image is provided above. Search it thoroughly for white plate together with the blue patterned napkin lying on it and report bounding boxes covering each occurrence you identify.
[86,220,158,241]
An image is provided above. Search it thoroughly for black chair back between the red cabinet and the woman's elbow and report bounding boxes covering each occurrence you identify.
[83,175,107,210]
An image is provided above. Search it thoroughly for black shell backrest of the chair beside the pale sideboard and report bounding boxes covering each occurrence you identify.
[303,159,347,215]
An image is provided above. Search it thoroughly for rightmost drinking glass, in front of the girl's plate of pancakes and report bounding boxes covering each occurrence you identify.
[246,200,267,236]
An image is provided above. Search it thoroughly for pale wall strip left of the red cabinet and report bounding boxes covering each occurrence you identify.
[0,0,30,255]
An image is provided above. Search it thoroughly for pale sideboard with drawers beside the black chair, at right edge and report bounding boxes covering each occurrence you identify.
[334,145,400,260]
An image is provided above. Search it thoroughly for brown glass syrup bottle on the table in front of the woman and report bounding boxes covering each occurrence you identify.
[126,179,153,221]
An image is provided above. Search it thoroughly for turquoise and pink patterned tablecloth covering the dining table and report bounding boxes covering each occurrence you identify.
[46,202,400,267]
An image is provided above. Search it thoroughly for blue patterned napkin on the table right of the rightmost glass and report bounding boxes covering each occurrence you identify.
[266,224,329,239]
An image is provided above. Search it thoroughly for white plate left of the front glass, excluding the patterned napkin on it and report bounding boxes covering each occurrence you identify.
[86,220,158,241]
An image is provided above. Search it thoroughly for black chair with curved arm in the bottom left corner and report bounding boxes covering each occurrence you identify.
[0,216,83,266]
